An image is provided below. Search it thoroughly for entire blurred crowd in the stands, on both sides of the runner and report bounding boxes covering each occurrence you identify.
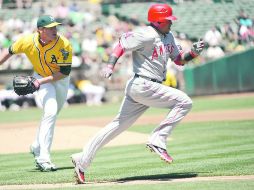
[0,0,254,108]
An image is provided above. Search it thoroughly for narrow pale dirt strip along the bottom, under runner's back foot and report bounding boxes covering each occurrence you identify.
[0,175,254,190]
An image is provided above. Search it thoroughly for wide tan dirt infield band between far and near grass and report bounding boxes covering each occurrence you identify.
[0,109,254,154]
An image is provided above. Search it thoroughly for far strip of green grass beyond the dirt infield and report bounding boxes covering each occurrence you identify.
[0,93,254,123]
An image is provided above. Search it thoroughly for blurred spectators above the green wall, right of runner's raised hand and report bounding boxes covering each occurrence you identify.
[201,10,254,61]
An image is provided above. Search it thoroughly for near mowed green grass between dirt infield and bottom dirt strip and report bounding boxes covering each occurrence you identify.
[0,121,254,186]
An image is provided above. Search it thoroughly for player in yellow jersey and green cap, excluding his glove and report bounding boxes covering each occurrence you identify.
[0,15,72,171]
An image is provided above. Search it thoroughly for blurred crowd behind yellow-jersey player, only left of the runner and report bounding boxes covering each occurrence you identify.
[0,1,136,110]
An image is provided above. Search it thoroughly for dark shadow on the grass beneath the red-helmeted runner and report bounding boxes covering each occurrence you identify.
[116,172,198,183]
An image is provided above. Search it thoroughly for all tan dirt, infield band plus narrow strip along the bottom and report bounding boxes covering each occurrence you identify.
[0,94,254,190]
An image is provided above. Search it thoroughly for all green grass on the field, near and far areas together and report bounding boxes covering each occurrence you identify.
[0,94,254,190]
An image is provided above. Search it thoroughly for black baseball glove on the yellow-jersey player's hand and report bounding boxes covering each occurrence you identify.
[13,76,40,96]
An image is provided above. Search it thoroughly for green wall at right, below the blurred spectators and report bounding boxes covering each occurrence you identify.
[184,48,254,95]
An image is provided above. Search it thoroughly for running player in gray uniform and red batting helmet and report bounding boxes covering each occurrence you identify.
[71,4,204,183]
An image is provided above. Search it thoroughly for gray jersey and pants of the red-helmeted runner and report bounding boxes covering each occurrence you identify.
[75,26,192,169]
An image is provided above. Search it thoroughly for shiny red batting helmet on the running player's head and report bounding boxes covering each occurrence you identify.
[148,4,177,22]
